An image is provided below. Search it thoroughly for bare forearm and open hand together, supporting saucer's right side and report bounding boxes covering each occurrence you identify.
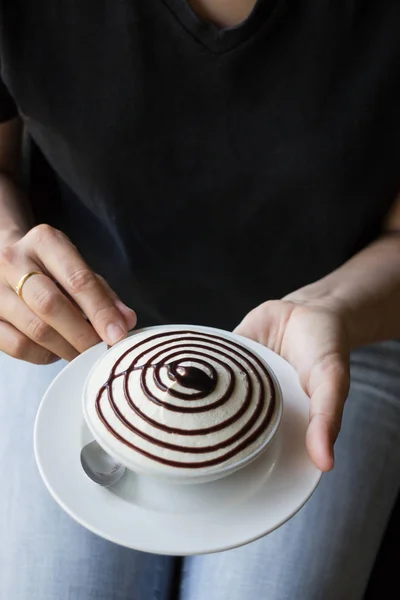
[236,223,400,471]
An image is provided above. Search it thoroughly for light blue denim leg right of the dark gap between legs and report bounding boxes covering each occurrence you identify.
[181,342,400,600]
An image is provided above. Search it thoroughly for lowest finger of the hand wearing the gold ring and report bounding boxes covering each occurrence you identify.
[0,321,59,365]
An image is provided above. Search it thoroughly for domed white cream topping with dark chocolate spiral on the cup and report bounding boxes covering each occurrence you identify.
[85,328,277,472]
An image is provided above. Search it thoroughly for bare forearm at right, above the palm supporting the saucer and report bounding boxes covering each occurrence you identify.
[286,233,400,348]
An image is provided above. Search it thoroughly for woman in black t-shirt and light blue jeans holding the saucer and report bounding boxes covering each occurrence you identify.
[0,0,400,600]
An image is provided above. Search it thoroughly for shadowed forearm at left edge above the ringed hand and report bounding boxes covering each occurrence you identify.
[0,173,31,248]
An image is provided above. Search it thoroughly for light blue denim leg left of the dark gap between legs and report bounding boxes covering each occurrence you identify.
[0,354,173,600]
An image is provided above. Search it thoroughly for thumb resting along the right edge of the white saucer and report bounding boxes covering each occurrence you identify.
[306,354,350,471]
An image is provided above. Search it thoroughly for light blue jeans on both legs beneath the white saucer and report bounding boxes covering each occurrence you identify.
[0,342,400,600]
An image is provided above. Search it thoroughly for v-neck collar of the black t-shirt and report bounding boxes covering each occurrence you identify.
[163,0,286,54]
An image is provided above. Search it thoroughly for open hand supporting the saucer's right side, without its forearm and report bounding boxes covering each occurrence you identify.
[235,295,350,471]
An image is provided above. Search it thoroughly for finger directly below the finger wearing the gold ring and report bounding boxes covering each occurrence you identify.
[0,286,79,361]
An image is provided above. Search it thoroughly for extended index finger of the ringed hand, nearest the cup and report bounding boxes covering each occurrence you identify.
[27,226,128,345]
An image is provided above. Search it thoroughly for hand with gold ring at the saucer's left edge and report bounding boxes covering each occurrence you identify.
[0,225,136,364]
